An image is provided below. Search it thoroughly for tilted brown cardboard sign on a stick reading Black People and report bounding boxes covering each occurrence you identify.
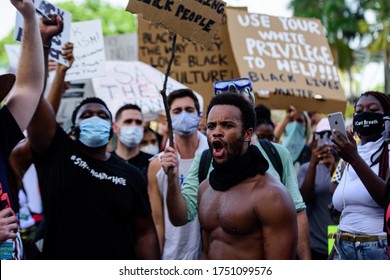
[126,0,226,47]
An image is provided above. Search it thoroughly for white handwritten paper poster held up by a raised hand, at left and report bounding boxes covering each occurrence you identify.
[65,19,106,81]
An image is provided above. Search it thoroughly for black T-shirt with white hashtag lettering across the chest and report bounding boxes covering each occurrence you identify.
[35,126,151,260]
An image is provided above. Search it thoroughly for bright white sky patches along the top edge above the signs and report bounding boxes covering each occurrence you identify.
[0,0,292,39]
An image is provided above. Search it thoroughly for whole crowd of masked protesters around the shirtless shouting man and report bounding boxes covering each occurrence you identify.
[0,0,390,260]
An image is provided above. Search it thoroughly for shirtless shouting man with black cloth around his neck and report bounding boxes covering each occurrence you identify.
[200,93,297,259]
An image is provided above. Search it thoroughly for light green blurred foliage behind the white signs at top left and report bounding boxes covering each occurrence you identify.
[0,0,137,68]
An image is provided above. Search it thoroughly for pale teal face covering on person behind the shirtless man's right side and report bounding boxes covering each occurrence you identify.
[282,121,306,162]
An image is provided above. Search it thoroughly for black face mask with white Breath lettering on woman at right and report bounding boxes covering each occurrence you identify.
[353,112,384,136]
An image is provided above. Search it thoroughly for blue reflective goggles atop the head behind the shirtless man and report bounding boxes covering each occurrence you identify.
[214,78,255,104]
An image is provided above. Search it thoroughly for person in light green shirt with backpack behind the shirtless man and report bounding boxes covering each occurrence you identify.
[161,84,310,260]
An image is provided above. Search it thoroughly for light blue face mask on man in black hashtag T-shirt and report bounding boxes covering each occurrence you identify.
[79,116,111,148]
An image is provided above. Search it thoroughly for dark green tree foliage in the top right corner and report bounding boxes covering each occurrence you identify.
[289,0,390,94]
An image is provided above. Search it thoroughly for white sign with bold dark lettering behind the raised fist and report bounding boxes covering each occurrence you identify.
[14,0,72,66]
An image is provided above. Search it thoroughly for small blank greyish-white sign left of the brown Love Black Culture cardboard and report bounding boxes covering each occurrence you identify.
[104,33,138,61]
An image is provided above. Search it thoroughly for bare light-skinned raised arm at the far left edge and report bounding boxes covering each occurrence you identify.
[5,0,44,131]
